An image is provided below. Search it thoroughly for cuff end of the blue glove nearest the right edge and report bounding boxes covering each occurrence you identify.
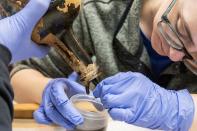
[177,89,194,131]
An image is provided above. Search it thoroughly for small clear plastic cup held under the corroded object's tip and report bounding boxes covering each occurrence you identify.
[70,94,108,131]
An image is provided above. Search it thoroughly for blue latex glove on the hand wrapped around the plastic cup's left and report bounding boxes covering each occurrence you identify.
[34,73,85,129]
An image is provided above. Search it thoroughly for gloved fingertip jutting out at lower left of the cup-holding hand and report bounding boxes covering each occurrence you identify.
[33,105,52,124]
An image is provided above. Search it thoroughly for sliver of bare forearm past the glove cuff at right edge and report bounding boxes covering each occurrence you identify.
[191,94,197,131]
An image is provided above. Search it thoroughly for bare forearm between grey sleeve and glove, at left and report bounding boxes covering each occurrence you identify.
[11,69,51,103]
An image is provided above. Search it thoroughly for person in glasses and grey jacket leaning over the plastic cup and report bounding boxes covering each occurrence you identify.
[11,0,197,131]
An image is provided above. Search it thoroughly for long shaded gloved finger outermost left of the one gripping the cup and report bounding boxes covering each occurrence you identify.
[43,88,75,129]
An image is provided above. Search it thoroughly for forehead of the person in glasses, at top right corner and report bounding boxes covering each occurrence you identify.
[179,0,197,47]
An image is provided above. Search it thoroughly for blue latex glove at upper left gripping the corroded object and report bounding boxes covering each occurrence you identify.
[0,0,51,62]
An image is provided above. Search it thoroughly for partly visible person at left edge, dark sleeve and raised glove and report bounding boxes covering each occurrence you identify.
[0,0,50,131]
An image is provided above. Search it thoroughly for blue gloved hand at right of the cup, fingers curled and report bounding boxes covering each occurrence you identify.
[93,72,194,131]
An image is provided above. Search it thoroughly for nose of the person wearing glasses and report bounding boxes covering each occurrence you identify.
[169,47,185,61]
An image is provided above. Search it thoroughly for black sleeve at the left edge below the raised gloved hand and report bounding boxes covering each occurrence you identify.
[0,44,14,131]
